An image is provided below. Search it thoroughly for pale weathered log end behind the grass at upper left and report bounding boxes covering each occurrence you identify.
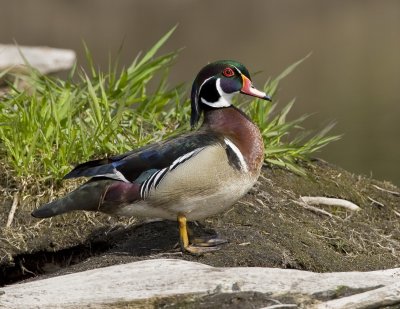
[0,44,76,74]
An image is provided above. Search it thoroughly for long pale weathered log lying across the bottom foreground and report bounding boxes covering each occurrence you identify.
[0,259,400,308]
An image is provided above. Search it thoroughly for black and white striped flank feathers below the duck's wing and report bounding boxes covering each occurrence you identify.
[140,147,204,199]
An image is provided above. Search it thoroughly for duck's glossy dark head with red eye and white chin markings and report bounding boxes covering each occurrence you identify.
[190,60,271,127]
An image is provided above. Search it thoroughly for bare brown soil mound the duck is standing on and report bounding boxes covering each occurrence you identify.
[0,160,400,285]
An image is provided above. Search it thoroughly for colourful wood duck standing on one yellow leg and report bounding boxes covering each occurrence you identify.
[32,60,270,254]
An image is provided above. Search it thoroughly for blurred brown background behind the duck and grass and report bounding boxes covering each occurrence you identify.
[0,0,400,185]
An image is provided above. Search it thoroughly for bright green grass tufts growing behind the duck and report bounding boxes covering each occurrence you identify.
[0,29,338,180]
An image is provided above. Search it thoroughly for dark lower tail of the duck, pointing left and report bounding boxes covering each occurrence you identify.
[32,180,115,218]
